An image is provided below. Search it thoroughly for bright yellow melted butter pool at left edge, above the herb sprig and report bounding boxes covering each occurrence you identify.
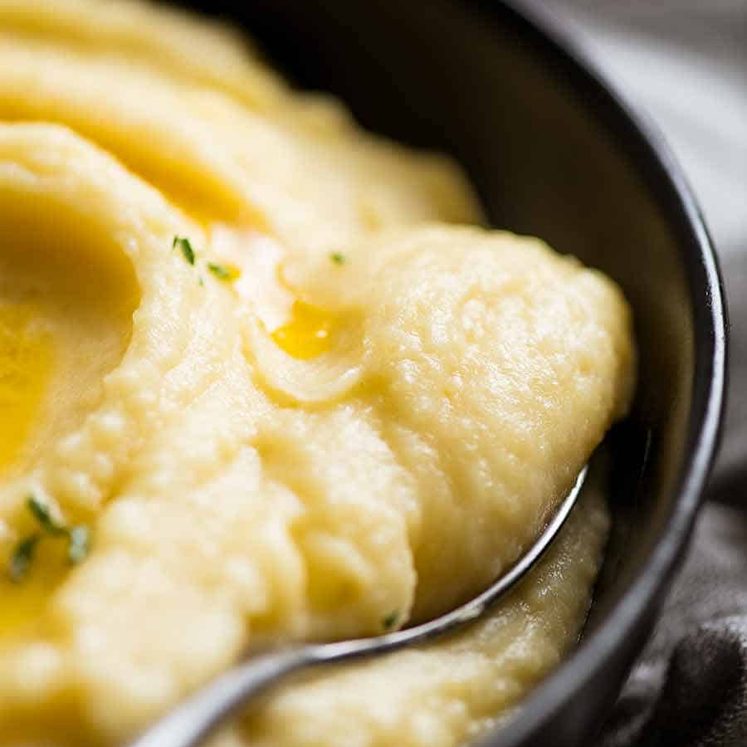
[0,303,53,475]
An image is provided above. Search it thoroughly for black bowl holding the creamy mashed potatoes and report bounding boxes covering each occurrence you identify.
[174,0,726,747]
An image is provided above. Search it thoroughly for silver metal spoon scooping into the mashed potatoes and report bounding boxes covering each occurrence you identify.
[130,467,587,747]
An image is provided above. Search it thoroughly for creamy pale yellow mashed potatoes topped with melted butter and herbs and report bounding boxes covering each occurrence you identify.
[0,0,633,747]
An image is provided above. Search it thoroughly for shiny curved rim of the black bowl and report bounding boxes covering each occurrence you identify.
[470,0,728,747]
